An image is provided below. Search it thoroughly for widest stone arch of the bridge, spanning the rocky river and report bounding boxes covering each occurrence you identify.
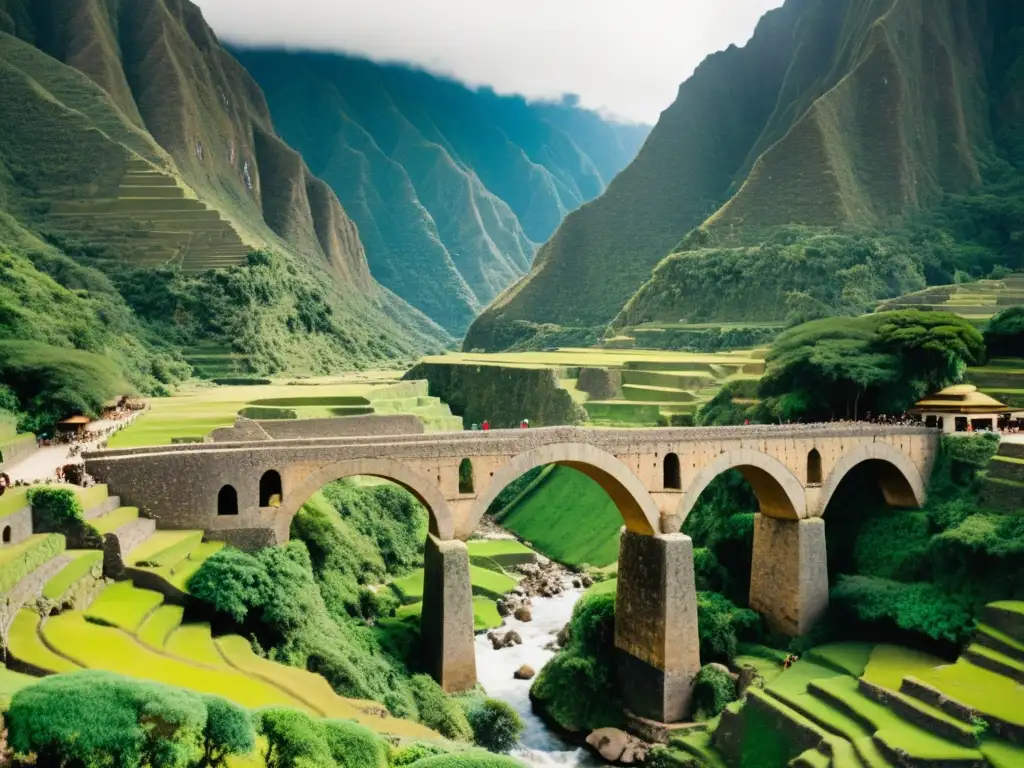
[459,442,659,538]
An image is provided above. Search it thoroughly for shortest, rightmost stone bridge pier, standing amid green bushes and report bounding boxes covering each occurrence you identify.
[751,514,828,637]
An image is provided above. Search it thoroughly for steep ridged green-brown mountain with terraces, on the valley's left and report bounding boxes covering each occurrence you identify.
[0,0,449,381]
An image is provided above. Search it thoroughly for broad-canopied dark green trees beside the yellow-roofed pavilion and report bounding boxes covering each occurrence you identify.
[760,310,985,421]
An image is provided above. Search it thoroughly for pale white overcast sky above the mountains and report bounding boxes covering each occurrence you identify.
[195,0,782,123]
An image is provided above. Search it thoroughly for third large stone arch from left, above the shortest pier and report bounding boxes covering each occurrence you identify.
[676,449,807,525]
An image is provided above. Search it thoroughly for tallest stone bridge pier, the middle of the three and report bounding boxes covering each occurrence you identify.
[615,529,700,723]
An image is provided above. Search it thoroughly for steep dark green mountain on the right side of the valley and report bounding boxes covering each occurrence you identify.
[465,0,1024,349]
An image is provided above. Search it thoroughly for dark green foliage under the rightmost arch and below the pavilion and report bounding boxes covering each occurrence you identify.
[825,435,1024,647]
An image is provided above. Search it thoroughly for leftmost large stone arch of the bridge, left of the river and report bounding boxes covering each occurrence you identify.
[281,459,455,541]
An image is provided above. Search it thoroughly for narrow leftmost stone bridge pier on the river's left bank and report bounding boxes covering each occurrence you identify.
[420,535,476,693]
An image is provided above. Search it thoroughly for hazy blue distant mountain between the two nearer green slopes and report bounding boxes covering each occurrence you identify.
[233,49,648,334]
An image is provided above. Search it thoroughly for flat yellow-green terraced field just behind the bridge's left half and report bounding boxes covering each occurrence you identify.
[110,372,462,447]
